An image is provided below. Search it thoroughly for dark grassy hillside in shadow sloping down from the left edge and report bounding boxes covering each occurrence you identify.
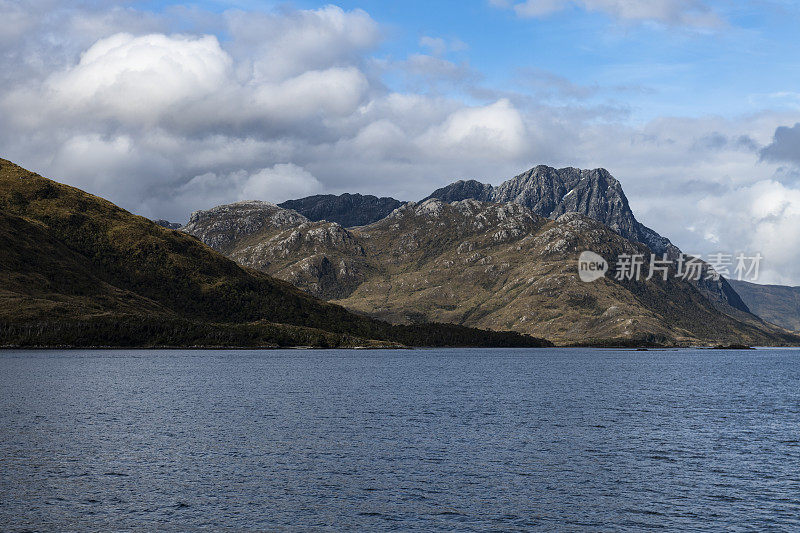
[0,159,545,346]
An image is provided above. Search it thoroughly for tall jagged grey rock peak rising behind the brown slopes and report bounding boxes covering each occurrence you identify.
[423,165,750,313]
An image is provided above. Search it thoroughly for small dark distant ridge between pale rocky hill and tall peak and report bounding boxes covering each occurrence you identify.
[279,193,403,228]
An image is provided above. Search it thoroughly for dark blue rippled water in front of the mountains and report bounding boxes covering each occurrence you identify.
[0,350,800,531]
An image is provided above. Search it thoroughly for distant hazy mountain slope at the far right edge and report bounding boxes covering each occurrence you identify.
[730,279,800,331]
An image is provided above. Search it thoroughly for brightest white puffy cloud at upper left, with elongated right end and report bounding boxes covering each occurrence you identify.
[0,29,368,133]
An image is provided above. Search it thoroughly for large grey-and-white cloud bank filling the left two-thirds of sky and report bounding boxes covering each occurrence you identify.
[0,6,526,220]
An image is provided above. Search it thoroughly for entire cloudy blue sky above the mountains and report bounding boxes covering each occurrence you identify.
[0,0,800,285]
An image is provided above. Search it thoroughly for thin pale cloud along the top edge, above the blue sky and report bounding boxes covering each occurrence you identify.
[491,0,721,27]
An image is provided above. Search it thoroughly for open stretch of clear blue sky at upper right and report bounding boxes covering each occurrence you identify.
[133,0,800,121]
